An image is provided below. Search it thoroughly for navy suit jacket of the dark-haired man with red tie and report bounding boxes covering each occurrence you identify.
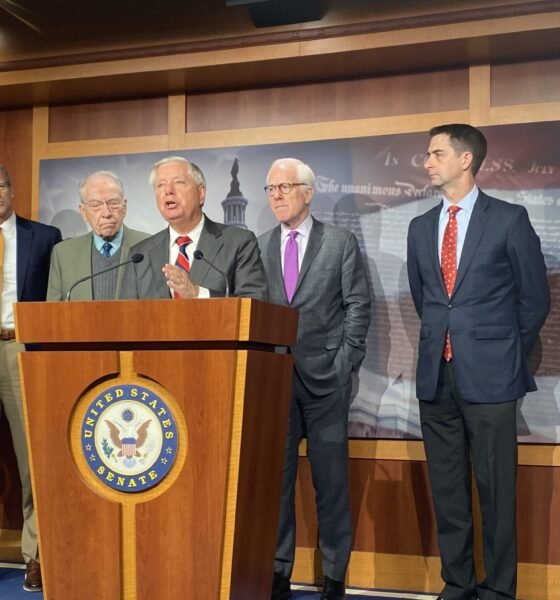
[407,192,550,403]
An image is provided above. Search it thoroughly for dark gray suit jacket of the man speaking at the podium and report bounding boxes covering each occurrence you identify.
[120,217,268,300]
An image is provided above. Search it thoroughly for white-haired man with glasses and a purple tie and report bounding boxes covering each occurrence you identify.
[259,158,370,600]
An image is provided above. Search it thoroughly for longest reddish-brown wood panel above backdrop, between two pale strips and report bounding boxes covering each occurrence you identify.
[187,68,469,132]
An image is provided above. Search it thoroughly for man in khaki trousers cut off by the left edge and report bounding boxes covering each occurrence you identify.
[0,165,61,592]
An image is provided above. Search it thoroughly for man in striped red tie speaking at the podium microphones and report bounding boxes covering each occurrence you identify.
[120,156,268,300]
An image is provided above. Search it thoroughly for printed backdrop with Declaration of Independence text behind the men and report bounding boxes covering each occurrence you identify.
[39,122,560,443]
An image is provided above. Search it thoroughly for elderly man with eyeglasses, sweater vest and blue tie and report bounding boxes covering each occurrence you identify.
[47,171,148,300]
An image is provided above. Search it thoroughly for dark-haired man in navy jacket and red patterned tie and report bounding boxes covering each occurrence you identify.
[408,125,550,600]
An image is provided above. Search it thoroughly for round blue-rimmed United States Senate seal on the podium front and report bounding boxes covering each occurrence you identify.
[80,384,179,493]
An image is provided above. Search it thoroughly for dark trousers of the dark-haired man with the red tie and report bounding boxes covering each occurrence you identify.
[420,360,517,600]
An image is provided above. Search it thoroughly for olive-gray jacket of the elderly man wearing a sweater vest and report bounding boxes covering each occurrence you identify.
[47,225,148,301]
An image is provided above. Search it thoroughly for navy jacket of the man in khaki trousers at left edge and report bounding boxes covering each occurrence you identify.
[16,215,62,302]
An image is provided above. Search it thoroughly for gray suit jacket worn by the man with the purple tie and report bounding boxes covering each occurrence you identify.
[259,219,371,395]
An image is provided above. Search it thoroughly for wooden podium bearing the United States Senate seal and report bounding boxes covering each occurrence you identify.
[15,298,297,600]
